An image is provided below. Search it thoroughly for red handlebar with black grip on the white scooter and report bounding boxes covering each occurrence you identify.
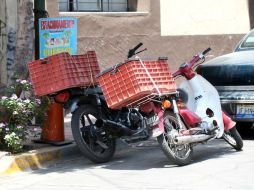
[173,47,212,77]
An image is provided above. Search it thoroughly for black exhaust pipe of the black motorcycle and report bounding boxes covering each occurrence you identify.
[95,119,140,136]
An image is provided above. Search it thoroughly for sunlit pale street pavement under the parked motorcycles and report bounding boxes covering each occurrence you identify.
[0,135,254,190]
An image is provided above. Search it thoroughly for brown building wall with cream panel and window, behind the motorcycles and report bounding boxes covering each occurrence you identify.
[46,0,251,69]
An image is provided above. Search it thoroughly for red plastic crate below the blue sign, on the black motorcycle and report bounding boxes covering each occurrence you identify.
[28,51,100,96]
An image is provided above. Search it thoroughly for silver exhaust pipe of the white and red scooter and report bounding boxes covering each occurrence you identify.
[175,134,214,144]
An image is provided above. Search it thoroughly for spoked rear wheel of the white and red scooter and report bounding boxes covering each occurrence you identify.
[157,112,193,166]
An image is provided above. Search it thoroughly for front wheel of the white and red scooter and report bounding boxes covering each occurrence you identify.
[222,126,243,151]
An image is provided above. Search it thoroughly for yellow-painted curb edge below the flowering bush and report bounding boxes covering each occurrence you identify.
[0,143,79,176]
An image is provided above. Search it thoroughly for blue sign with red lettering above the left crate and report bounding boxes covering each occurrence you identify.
[39,17,77,58]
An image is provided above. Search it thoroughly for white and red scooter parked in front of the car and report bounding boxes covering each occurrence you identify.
[157,48,243,165]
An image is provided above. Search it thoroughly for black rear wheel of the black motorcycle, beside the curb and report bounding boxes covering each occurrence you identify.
[71,105,116,163]
